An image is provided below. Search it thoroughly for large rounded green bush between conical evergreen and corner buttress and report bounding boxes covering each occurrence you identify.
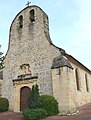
[40,95,59,116]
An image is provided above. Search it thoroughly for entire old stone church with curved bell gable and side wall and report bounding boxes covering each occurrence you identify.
[0,5,91,114]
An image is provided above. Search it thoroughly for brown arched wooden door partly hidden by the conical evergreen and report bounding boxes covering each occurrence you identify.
[20,86,31,111]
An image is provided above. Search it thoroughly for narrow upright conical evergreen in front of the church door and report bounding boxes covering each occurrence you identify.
[29,84,40,109]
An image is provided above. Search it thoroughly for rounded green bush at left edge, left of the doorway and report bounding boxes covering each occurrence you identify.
[0,98,9,112]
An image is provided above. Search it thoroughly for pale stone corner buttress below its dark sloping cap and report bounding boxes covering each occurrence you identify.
[52,67,76,115]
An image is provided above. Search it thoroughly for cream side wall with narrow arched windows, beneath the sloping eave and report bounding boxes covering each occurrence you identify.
[67,56,91,107]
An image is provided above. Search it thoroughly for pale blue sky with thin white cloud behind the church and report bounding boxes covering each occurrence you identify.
[0,0,91,70]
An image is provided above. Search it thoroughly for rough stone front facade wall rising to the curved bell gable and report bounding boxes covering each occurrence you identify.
[2,6,61,109]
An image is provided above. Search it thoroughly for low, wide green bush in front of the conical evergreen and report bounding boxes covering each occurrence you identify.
[22,108,47,120]
